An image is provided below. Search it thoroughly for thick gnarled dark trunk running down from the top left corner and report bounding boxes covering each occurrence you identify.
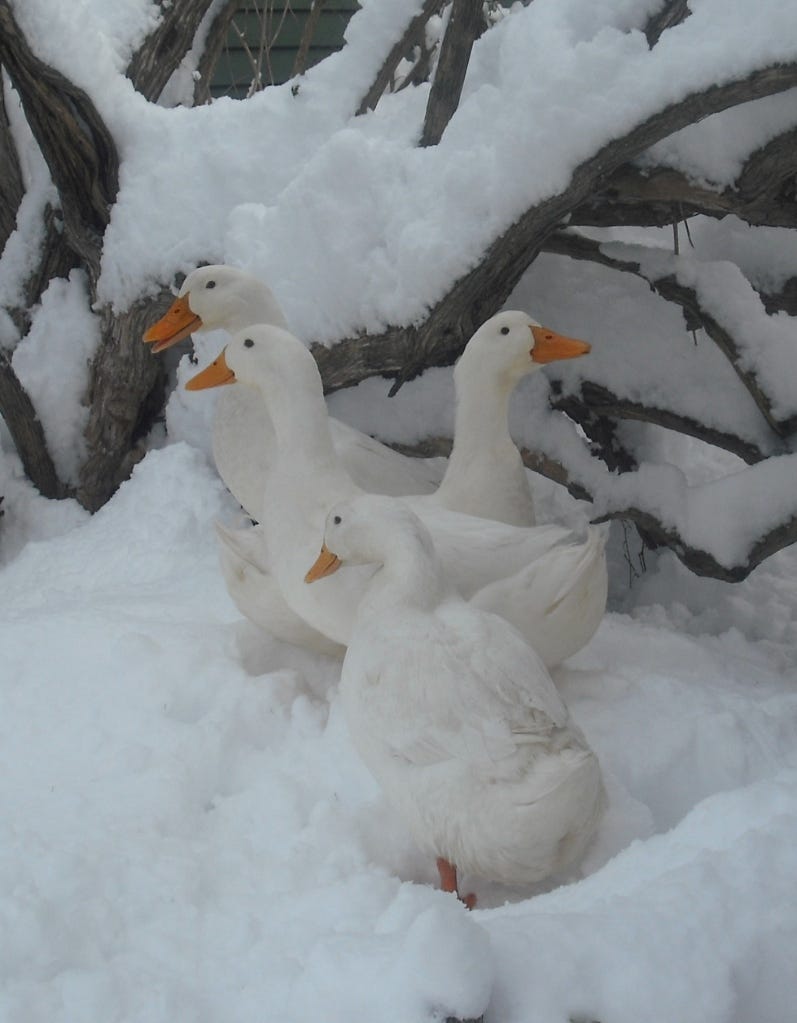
[0,0,181,510]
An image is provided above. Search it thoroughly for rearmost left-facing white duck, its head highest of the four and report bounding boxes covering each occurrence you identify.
[143,264,445,521]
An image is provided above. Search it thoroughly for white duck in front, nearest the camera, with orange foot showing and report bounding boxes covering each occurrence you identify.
[305,494,605,908]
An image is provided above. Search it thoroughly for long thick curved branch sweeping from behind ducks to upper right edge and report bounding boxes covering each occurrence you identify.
[313,63,797,391]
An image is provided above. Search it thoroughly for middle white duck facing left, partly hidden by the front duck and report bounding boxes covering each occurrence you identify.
[186,324,606,666]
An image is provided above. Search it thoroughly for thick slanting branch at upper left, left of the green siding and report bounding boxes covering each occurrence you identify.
[127,0,219,100]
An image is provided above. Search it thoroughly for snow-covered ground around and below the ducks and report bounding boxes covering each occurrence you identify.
[0,425,797,1023]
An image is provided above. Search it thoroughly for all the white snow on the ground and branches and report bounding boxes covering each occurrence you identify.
[0,0,797,1023]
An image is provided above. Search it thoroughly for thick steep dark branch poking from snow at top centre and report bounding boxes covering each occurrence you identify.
[419,0,483,146]
